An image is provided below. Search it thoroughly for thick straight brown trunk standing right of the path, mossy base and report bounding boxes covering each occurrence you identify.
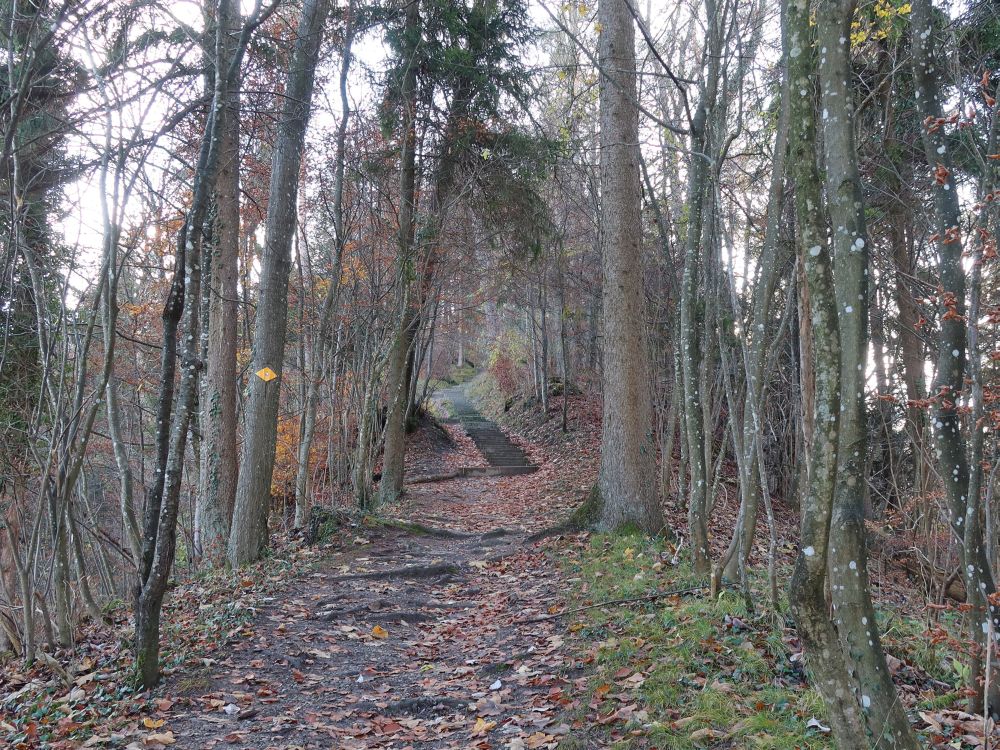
[592,0,663,533]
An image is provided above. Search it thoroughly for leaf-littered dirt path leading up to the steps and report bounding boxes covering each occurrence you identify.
[160,404,572,750]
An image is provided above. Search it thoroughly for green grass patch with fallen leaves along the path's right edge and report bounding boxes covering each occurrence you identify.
[560,534,833,750]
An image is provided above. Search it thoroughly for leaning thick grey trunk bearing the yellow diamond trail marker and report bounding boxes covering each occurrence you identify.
[228,0,330,566]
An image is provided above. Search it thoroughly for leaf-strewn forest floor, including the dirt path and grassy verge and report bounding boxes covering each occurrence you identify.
[0,382,985,750]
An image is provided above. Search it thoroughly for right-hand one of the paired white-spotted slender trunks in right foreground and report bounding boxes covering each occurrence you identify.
[817,0,919,750]
